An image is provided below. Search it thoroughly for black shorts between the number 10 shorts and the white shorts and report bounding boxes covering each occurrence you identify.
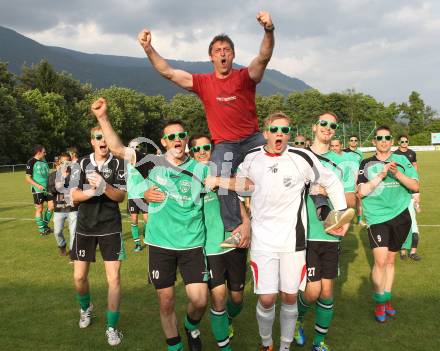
[206,249,248,291]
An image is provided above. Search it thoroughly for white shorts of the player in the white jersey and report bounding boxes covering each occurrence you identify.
[250,250,307,295]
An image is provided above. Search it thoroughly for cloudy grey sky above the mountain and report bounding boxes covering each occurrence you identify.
[0,0,440,111]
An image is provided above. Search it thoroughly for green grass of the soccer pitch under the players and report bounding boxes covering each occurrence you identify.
[0,152,440,351]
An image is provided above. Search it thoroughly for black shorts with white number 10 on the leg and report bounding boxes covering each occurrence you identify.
[148,245,208,289]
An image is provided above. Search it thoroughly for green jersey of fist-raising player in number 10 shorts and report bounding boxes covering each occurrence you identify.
[146,157,209,250]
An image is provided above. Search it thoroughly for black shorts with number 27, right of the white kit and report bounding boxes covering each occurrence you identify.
[306,241,339,282]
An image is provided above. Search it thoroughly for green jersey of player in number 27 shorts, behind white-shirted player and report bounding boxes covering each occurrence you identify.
[307,151,355,242]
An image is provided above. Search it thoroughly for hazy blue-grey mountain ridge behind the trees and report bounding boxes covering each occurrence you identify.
[0,26,311,99]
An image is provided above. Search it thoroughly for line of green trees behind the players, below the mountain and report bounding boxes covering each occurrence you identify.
[0,60,440,164]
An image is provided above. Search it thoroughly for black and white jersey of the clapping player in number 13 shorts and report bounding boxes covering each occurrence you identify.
[69,154,126,235]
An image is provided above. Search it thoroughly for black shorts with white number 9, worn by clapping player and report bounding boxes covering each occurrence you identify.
[368,209,412,252]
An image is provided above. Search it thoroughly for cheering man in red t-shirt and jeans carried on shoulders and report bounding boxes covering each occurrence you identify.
[138,11,275,232]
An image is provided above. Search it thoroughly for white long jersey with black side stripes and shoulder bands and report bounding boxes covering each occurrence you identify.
[237,146,347,252]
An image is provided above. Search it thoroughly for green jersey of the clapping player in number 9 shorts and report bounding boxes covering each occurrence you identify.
[358,154,419,225]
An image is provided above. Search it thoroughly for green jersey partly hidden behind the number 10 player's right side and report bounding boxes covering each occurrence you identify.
[203,191,234,256]
